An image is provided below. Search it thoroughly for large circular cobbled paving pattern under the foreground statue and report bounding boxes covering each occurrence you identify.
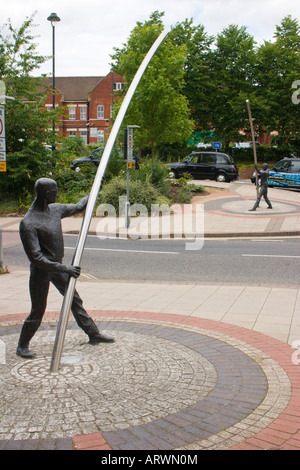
[0,319,291,450]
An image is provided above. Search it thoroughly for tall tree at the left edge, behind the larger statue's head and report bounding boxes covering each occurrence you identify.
[0,15,60,198]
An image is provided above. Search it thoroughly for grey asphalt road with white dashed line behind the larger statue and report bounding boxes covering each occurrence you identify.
[4,235,300,286]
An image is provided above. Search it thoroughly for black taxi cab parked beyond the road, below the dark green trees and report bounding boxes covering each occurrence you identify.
[168,152,239,182]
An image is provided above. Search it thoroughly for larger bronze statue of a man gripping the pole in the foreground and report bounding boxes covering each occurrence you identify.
[17,178,114,359]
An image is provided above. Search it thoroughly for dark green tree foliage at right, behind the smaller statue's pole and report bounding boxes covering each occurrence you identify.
[179,16,300,150]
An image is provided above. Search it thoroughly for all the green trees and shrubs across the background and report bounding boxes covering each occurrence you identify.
[0,11,300,208]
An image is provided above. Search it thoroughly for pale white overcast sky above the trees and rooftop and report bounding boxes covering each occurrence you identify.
[0,0,300,77]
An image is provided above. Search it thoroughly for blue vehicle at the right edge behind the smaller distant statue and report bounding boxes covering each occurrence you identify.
[251,158,300,188]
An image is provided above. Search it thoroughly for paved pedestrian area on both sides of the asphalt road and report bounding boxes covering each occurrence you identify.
[0,182,300,451]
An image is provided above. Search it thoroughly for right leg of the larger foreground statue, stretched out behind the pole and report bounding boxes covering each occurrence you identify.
[51,273,114,344]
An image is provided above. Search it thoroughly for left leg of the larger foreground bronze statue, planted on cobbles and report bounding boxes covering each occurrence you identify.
[17,268,49,359]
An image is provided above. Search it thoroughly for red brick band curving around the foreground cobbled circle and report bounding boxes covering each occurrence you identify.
[0,310,300,450]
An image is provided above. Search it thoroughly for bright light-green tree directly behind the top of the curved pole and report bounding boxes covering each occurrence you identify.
[112,12,193,158]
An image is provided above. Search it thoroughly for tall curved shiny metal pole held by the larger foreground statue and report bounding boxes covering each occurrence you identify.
[50,31,168,372]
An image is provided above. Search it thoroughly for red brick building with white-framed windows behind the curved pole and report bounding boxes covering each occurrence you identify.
[45,72,124,145]
